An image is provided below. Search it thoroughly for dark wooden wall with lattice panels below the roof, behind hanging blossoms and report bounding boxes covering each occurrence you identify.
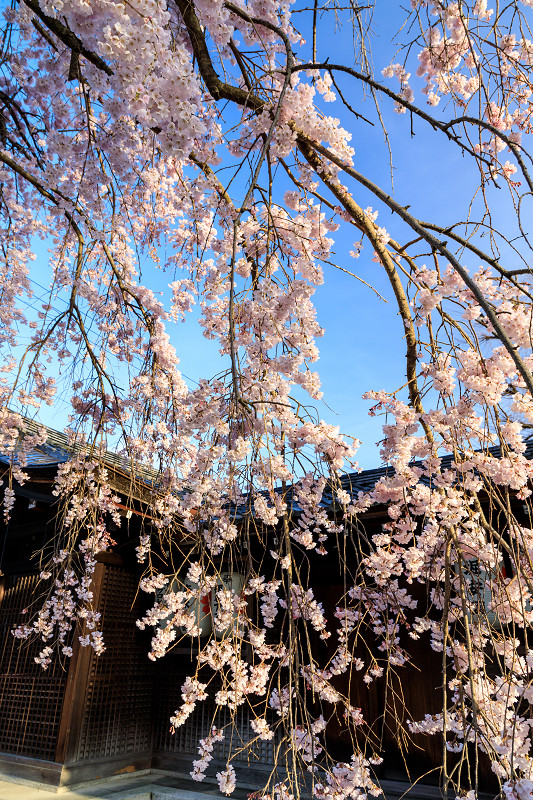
[0,536,498,784]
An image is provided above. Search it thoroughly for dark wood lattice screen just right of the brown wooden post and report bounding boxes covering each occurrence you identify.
[73,566,153,761]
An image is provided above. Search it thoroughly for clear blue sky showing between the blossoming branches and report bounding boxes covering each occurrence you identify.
[17,2,528,468]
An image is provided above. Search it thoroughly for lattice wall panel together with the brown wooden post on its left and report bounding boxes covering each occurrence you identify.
[57,563,153,782]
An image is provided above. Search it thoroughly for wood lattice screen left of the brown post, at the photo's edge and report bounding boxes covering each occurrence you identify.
[0,575,68,761]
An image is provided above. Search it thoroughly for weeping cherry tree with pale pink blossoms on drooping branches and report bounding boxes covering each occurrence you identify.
[0,0,533,800]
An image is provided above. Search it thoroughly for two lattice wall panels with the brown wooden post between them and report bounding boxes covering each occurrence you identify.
[0,563,154,783]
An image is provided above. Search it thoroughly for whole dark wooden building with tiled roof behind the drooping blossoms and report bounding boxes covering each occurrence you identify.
[0,431,524,786]
